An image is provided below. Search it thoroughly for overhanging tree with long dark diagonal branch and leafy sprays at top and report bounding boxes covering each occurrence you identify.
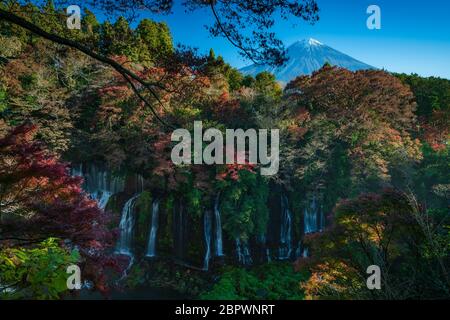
[0,0,318,125]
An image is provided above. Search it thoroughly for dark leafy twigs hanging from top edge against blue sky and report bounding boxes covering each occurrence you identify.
[26,0,319,65]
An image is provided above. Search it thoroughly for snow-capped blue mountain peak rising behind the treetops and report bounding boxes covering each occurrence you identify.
[240,39,376,84]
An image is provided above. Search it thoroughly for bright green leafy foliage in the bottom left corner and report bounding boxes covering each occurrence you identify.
[0,238,79,299]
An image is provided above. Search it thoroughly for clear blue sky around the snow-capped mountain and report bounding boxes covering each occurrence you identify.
[139,0,450,79]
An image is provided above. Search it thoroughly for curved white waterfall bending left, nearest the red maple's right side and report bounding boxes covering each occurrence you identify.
[116,194,140,257]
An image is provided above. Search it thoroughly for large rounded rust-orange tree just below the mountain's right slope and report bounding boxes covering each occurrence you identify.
[286,66,421,195]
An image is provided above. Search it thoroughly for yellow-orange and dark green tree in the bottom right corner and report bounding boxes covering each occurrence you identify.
[300,189,450,299]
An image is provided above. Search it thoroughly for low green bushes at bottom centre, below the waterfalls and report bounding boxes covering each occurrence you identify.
[200,262,308,300]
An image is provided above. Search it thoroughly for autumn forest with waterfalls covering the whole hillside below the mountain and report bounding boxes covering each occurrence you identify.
[0,1,450,300]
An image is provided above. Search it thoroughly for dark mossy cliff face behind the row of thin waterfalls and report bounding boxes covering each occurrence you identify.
[82,165,326,269]
